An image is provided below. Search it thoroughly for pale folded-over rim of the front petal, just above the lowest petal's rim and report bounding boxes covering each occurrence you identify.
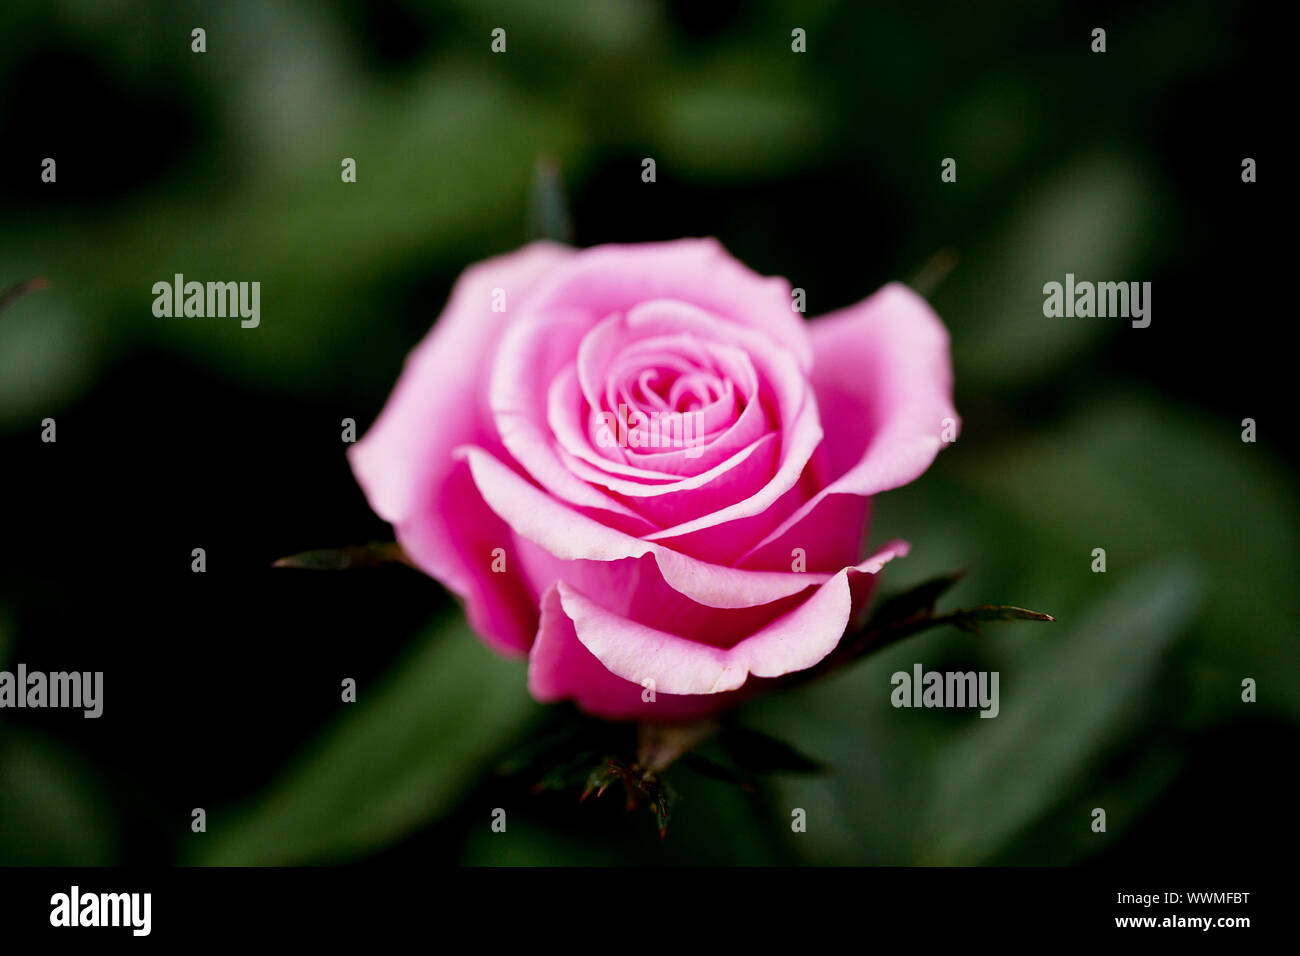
[454,445,852,607]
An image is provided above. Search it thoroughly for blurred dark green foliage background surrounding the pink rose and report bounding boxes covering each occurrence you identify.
[0,0,1300,865]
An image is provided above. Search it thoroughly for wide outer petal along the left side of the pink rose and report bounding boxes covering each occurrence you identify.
[348,243,573,652]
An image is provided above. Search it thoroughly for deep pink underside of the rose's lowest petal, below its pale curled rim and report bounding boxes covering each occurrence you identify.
[528,585,735,722]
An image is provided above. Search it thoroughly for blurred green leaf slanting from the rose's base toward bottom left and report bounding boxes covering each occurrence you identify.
[190,618,541,865]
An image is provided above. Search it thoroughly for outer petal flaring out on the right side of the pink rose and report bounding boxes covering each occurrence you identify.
[737,282,961,564]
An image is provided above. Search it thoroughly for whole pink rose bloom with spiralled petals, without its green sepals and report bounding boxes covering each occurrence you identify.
[350,239,957,722]
